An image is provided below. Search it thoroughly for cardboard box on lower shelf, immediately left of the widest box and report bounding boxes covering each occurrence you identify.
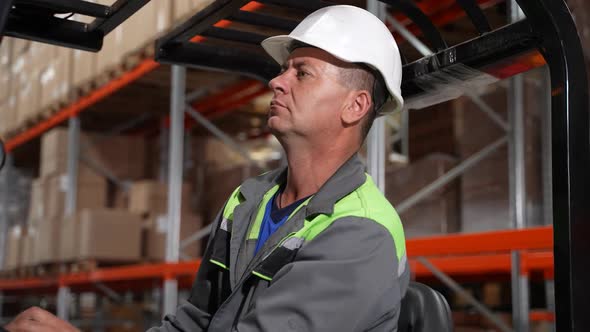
[33,217,63,264]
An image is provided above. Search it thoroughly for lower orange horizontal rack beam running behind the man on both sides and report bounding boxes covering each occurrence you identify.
[0,227,554,321]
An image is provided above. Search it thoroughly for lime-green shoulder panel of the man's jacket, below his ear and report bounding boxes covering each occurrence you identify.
[297,175,406,260]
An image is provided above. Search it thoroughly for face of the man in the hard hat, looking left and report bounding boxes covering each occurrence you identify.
[268,47,350,139]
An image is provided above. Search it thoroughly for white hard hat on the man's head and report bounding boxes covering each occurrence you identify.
[262,5,404,115]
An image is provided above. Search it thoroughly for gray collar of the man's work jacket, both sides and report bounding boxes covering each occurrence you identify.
[240,153,366,217]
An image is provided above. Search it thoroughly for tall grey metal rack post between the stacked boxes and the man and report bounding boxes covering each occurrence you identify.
[164,66,186,314]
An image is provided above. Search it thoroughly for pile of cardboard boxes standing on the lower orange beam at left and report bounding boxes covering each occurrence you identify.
[28,128,144,264]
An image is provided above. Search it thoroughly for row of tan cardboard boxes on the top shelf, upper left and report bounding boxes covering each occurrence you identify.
[0,0,222,134]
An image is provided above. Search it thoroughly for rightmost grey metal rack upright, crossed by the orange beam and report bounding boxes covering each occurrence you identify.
[508,1,529,332]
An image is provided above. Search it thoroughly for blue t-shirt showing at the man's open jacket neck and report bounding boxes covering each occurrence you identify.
[254,189,309,255]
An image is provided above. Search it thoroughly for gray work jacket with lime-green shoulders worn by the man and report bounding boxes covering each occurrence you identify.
[149,155,409,332]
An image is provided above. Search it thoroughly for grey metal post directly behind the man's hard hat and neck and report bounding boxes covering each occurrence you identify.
[367,0,386,192]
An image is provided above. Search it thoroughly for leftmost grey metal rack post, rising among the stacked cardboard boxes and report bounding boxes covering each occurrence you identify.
[57,117,80,320]
